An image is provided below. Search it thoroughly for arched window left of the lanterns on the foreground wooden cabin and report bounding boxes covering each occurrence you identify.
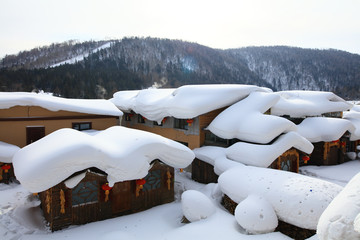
[72,180,99,207]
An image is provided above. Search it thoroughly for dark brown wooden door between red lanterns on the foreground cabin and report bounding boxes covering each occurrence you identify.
[110,181,135,214]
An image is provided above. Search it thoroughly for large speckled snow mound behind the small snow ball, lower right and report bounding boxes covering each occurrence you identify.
[218,166,342,229]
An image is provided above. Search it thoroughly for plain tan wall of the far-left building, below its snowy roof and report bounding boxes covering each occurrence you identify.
[0,106,119,147]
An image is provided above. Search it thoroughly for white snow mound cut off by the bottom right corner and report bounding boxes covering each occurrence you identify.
[317,173,360,240]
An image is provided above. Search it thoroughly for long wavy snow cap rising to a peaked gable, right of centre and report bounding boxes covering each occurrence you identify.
[194,132,314,169]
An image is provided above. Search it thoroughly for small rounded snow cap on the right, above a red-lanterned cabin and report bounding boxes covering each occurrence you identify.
[298,117,355,143]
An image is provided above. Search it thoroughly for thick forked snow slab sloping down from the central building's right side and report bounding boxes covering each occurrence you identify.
[207,92,296,143]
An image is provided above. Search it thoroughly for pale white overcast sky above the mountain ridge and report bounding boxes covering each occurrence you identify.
[0,0,360,58]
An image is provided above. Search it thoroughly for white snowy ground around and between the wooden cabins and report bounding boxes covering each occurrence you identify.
[0,160,360,240]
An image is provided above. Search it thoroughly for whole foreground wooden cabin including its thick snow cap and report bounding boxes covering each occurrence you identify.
[13,126,194,231]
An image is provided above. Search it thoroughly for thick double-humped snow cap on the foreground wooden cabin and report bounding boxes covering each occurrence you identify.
[13,126,194,192]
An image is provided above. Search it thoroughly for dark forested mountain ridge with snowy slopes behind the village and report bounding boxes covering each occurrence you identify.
[0,38,360,99]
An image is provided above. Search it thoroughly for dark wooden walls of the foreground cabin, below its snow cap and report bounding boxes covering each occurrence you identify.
[38,160,174,231]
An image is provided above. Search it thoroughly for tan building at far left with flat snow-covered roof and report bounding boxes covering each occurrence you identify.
[0,93,122,182]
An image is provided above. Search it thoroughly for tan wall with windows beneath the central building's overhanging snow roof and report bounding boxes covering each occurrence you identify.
[121,108,224,149]
